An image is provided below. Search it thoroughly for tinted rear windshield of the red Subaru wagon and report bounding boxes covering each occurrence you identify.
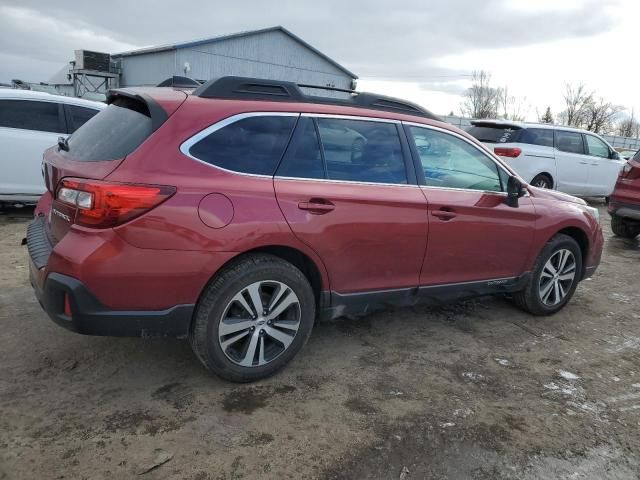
[60,98,153,162]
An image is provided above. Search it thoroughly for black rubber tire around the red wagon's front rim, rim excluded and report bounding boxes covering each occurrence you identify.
[513,234,582,316]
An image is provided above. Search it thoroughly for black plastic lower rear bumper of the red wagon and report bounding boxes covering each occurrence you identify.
[31,270,194,338]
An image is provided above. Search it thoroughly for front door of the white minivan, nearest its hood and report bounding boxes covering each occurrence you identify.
[584,134,625,197]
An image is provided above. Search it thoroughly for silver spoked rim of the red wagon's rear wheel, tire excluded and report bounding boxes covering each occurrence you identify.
[218,280,301,367]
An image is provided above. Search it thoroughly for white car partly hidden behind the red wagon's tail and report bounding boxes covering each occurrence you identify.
[0,88,106,203]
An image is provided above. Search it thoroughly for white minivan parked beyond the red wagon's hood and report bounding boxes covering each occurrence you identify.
[468,120,626,197]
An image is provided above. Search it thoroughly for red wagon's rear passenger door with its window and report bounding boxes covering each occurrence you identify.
[274,115,427,293]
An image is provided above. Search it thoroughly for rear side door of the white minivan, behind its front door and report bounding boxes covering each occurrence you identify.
[555,130,591,195]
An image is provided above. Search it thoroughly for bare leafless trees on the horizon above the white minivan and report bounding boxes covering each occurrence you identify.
[461,70,640,138]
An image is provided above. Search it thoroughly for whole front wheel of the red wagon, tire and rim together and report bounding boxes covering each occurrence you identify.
[513,234,582,315]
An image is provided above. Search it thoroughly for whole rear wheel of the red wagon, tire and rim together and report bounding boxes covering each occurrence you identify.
[189,254,315,382]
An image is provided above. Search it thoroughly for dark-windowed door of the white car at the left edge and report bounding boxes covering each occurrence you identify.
[0,99,66,196]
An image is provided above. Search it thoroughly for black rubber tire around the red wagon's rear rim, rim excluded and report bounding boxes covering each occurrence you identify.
[189,254,316,382]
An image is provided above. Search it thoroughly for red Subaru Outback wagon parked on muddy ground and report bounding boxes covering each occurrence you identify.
[27,77,603,382]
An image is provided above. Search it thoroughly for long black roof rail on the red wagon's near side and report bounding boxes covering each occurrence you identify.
[192,76,442,121]
